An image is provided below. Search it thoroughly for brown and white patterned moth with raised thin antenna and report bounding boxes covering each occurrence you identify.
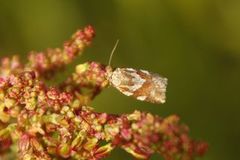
[106,41,167,103]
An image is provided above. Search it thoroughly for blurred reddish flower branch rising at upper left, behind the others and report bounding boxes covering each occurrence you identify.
[0,26,95,78]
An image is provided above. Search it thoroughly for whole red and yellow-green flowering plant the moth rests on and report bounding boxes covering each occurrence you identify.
[0,26,207,160]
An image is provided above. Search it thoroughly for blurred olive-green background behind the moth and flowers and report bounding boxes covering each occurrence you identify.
[0,0,240,160]
